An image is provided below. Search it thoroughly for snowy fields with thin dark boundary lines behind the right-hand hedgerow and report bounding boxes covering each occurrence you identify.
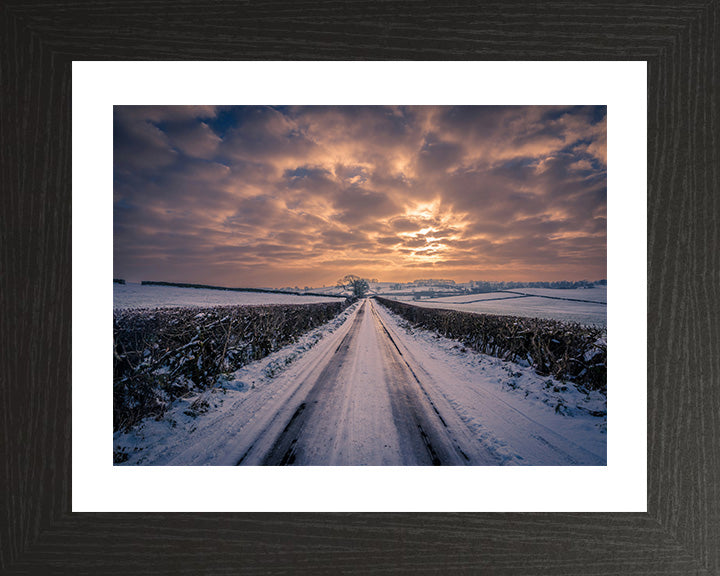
[386,287,607,327]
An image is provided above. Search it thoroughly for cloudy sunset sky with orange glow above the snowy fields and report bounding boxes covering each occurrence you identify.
[114,106,607,287]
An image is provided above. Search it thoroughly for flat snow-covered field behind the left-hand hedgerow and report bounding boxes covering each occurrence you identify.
[113,284,339,310]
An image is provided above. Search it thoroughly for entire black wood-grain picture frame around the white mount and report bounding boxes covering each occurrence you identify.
[0,0,720,575]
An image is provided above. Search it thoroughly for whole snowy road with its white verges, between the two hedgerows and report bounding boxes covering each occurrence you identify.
[115,300,606,466]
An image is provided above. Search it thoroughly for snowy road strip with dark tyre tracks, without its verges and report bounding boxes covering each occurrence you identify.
[238,300,497,466]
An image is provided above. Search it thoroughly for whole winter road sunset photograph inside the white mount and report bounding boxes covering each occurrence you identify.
[112,103,608,467]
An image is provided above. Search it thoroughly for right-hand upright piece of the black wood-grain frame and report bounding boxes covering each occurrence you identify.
[648,2,720,574]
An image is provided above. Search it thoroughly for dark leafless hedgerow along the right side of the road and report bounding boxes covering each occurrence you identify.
[376,297,607,392]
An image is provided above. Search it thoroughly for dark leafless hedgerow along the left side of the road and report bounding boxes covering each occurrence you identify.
[113,301,348,430]
